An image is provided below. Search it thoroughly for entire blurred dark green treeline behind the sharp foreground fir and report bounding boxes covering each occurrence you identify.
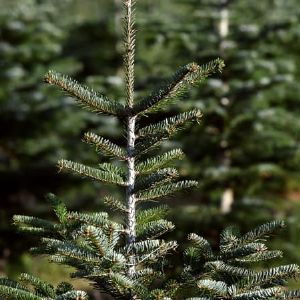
[0,0,300,290]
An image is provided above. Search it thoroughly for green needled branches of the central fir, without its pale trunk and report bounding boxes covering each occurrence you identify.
[19,56,222,299]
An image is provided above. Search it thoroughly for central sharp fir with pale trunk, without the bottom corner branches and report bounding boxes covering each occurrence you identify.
[0,1,224,299]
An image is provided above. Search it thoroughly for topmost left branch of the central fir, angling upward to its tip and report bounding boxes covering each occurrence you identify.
[45,71,126,116]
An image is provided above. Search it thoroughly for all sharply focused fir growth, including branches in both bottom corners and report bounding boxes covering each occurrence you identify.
[0,0,299,300]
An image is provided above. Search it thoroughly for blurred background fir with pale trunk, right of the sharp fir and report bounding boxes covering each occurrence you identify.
[138,0,300,258]
